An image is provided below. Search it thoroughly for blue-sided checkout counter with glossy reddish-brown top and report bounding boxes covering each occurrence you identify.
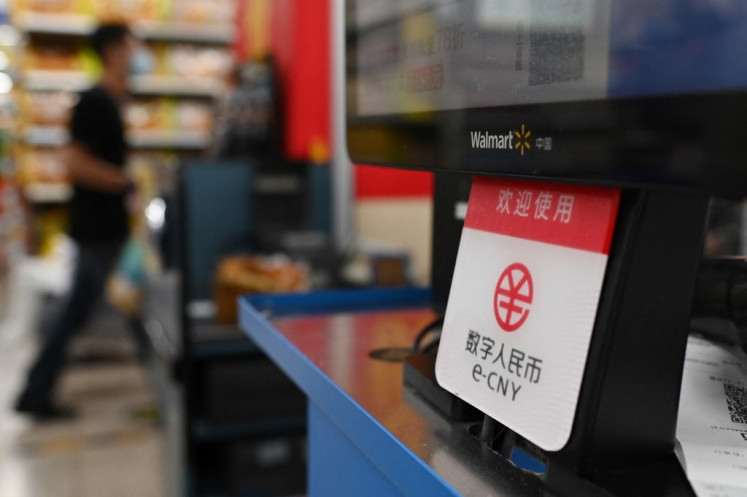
[239,294,553,497]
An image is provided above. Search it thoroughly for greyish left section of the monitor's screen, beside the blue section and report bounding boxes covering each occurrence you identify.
[356,0,610,115]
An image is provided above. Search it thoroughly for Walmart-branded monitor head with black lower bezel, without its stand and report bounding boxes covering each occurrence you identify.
[346,0,747,195]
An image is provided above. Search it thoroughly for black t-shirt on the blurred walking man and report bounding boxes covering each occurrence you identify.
[70,86,128,242]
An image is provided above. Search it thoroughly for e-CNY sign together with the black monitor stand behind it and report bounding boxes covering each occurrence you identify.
[436,178,708,495]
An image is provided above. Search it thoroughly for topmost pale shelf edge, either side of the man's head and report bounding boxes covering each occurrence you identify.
[16,12,236,45]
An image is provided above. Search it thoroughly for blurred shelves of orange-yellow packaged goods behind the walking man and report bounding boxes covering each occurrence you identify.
[10,0,236,253]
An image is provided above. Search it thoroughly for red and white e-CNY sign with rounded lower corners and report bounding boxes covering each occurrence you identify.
[436,178,620,451]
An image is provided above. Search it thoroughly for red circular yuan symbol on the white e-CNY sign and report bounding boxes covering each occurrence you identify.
[493,262,534,332]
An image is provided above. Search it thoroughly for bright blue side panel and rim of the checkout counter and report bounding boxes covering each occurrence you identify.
[240,299,459,496]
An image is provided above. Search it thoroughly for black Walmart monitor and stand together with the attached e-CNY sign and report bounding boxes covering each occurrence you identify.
[347,0,747,496]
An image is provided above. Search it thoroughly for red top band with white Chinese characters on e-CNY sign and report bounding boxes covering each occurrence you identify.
[464,178,620,254]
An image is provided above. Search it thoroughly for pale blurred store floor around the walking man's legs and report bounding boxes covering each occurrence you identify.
[0,320,165,497]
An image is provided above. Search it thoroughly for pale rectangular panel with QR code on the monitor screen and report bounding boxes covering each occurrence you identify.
[529,0,586,86]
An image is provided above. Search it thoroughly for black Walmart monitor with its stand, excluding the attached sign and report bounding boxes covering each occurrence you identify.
[346,0,747,495]
